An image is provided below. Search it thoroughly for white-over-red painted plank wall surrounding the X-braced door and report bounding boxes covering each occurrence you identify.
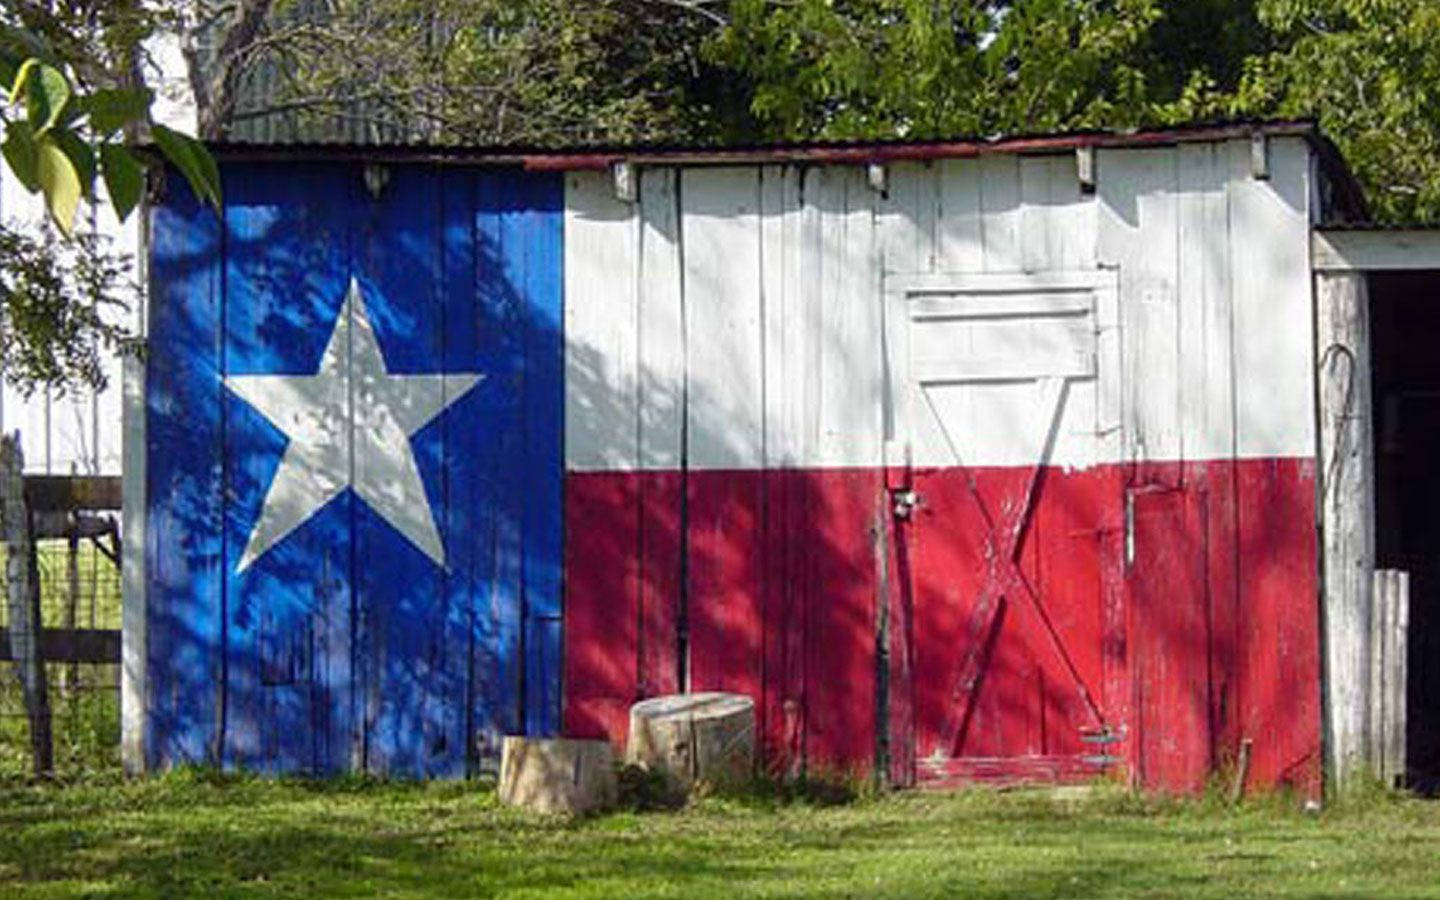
[564,138,1320,785]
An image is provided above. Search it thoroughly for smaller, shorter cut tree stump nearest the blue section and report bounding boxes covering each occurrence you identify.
[500,734,619,815]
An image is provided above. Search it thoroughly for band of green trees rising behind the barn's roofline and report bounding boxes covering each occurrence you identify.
[163,0,1440,220]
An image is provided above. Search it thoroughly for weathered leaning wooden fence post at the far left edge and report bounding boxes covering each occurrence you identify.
[0,433,55,775]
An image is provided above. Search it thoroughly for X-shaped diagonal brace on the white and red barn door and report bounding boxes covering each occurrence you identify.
[920,376,1106,757]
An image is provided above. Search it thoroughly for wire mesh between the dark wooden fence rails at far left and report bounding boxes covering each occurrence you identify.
[0,540,121,779]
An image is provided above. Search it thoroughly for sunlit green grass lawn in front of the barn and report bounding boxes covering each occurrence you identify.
[0,772,1440,897]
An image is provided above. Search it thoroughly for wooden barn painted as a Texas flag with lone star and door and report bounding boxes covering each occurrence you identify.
[124,122,1404,795]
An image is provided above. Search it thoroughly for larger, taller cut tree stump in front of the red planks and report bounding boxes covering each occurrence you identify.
[625,693,755,788]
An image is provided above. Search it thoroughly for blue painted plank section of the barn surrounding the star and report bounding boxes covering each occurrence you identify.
[147,164,563,776]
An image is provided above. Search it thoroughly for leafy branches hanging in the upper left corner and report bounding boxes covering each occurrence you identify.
[0,0,220,392]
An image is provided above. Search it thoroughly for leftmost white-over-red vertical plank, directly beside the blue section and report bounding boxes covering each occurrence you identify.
[558,173,639,737]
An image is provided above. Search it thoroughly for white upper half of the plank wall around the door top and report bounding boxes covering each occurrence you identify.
[566,138,1315,471]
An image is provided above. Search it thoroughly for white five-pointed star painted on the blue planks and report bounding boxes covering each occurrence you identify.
[225,278,484,572]
